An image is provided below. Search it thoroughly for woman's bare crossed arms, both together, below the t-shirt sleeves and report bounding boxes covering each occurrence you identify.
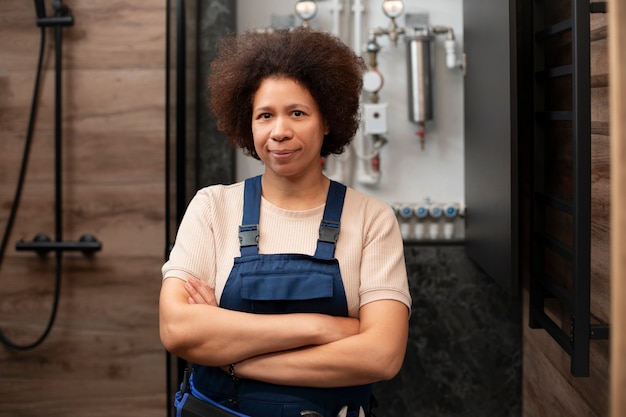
[159,278,408,387]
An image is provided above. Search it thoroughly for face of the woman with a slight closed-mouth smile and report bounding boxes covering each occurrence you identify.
[252,78,328,178]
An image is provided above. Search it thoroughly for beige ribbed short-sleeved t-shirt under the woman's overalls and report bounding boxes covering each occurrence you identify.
[162,182,411,317]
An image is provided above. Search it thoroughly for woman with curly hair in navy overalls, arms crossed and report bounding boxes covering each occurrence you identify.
[160,29,411,417]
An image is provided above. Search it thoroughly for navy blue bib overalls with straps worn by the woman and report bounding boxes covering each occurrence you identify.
[174,176,371,417]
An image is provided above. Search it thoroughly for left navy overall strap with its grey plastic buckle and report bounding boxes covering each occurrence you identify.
[239,175,261,256]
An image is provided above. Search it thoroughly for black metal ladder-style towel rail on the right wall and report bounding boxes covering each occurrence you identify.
[529,0,609,376]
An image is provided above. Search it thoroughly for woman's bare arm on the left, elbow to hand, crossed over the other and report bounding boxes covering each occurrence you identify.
[159,278,359,366]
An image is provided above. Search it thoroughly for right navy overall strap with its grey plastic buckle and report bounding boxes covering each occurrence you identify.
[315,180,346,259]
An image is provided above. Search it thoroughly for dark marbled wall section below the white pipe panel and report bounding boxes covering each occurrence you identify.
[374,244,522,417]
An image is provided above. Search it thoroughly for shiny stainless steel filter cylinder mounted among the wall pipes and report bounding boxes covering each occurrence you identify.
[405,34,433,123]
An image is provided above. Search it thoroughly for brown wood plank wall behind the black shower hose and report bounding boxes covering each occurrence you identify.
[0,0,166,417]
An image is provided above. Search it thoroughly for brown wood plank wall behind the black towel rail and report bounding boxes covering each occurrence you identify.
[522,1,611,417]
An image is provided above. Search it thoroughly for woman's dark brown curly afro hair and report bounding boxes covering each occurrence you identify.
[208,28,365,159]
